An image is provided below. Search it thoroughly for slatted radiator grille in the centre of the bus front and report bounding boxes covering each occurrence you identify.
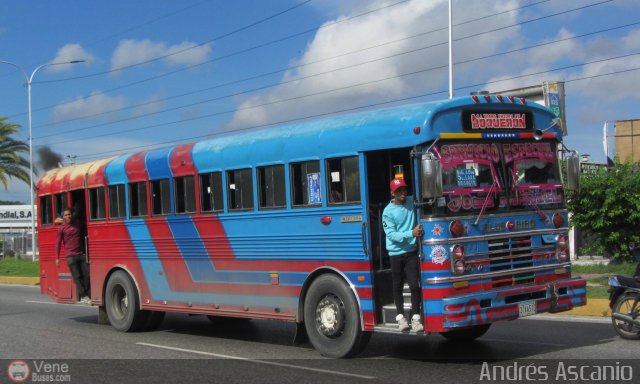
[488,237,534,288]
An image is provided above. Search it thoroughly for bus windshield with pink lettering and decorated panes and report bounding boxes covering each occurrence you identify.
[425,142,564,216]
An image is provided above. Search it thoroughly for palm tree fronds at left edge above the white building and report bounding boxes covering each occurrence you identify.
[0,117,30,190]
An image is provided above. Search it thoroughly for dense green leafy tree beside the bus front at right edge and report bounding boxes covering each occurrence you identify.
[568,159,640,261]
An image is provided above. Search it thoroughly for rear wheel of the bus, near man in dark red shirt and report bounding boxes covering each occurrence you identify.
[105,271,149,332]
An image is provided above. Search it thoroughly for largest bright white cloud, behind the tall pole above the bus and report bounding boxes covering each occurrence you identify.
[228,0,518,129]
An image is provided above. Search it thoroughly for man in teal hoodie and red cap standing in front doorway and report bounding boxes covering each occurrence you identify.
[382,179,424,332]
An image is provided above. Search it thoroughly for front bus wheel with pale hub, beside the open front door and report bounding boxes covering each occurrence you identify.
[304,275,371,357]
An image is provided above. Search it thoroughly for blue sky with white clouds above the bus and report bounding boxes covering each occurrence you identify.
[0,0,640,203]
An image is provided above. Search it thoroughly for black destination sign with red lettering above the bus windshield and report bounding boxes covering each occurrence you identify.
[462,111,533,132]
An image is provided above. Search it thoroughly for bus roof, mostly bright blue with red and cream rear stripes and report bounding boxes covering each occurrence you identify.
[38,95,562,194]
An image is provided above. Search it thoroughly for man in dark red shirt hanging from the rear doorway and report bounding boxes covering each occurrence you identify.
[56,208,91,304]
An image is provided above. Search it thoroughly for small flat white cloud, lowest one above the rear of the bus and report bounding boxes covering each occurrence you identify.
[53,92,127,122]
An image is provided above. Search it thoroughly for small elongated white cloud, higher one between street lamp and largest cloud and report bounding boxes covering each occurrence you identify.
[111,39,212,70]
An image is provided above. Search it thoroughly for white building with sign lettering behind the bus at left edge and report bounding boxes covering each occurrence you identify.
[0,205,33,258]
